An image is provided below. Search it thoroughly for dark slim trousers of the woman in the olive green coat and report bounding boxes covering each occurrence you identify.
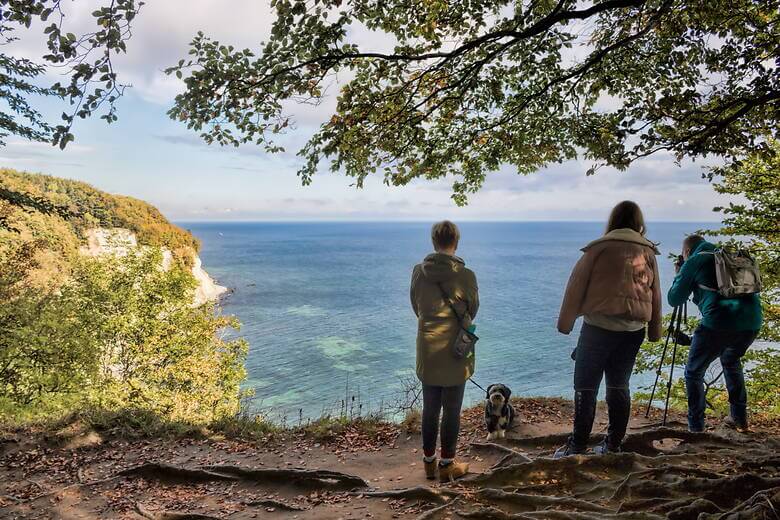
[422,383,466,459]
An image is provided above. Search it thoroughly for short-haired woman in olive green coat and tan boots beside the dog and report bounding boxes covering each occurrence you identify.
[411,220,479,481]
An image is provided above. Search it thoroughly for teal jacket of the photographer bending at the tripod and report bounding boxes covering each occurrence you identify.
[668,241,762,330]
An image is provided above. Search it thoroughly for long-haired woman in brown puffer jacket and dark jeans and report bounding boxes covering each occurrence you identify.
[555,201,661,458]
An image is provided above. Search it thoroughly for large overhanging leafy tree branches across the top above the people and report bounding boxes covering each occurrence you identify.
[168,0,780,204]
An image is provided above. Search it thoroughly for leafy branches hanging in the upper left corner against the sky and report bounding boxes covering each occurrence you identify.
[0,0,143,148]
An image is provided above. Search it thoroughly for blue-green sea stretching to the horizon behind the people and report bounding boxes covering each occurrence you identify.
[187,222,716,423]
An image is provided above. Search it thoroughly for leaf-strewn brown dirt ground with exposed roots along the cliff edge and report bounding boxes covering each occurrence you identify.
[0,399,780,520]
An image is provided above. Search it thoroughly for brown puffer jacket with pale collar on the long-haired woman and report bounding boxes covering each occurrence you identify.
[558,229,661,341]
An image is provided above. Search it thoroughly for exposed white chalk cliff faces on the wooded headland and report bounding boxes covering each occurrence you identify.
[80,228,227,306]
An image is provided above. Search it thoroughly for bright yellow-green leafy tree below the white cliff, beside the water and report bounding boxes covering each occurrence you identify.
[72,248,246,423]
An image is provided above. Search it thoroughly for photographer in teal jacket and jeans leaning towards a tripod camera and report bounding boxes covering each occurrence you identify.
[668,235,762,432]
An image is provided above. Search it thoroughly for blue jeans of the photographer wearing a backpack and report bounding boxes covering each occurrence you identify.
[685,325,758,432]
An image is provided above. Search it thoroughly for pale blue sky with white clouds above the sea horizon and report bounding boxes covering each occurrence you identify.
[0,0,724,222]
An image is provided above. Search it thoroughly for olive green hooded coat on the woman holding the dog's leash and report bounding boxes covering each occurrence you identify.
[410,253,479,386]
